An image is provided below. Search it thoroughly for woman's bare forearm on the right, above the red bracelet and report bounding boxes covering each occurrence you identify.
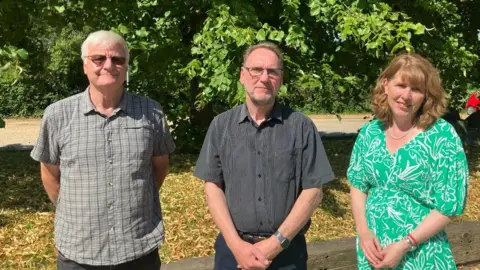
[411,210,452,244]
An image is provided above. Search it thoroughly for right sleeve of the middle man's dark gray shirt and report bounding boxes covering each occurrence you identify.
[301,122,335,189]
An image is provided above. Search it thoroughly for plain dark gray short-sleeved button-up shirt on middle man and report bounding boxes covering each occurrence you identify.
[194,103,335,233]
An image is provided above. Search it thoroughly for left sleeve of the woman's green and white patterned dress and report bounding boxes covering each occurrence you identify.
[347,127,370,193]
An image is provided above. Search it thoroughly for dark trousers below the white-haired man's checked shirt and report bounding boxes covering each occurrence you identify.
[57,248,161,270]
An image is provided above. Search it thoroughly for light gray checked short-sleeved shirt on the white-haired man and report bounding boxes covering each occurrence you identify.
[31,89,175,265]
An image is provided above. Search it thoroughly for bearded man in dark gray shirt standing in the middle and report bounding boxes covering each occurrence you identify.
[194,42,335,269]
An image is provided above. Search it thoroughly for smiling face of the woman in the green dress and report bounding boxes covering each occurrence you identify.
[383,72,425,122]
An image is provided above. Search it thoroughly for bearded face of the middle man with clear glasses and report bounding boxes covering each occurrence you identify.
[240,48,283,106]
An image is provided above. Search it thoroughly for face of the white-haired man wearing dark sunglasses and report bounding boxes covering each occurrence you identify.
[83,43,128,90]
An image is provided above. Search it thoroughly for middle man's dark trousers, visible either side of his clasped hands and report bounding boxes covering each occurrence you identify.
[214,234,308,270]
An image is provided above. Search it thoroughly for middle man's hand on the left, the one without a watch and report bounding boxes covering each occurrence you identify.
[231,240,271,270]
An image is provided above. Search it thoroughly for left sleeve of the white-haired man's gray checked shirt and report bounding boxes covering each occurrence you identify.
[30,106,60,165]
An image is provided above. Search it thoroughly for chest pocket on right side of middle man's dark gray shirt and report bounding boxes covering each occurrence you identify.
[272,148,298,182]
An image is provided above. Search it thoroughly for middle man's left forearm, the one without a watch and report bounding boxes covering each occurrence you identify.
[205,182,241,248]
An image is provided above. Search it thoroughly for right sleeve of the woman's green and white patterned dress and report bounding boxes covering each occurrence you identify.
[432,131,468,216]
